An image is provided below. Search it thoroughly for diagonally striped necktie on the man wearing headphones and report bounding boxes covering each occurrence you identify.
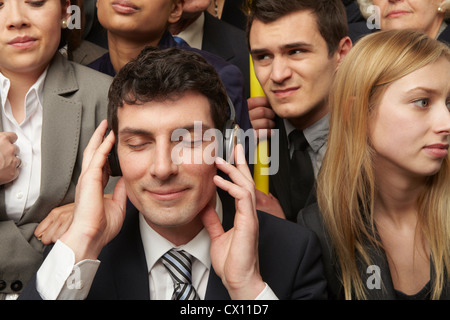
[162,249,200,300]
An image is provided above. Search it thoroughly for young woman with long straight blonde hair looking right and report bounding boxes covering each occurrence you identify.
[298,30,450,299]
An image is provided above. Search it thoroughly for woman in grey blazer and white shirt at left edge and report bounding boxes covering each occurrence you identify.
[0,0,111,299]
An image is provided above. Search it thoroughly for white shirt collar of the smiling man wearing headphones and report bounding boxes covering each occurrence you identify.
[139,193,223,272]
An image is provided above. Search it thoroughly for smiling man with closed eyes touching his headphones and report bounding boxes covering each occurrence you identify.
[21,48,326,299]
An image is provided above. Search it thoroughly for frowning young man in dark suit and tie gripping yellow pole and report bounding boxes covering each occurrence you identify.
[247,0,352,221]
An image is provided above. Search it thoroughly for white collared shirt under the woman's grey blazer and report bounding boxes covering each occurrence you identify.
[0,69,47,222]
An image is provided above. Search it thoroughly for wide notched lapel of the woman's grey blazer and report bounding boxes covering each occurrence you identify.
[21,54,82,223]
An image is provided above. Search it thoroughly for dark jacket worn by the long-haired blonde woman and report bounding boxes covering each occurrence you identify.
[298,203,450,300]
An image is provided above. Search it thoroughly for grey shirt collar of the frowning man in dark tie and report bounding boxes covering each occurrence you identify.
[283,113,330,152]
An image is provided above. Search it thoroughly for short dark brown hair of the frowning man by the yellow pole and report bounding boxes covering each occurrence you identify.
[246,0,348,56]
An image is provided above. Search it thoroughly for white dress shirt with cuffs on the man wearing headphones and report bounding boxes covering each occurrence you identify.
[36,195,277,300]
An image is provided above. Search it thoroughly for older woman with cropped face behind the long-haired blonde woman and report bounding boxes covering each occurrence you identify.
[350,0,450,43]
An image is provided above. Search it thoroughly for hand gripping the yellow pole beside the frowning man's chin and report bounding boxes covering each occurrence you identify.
[247,97,275,139]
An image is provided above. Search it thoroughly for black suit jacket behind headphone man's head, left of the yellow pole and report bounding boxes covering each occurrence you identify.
[202,11,250,98]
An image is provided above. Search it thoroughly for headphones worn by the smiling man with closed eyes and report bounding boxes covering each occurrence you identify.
[108,97,241,176]
